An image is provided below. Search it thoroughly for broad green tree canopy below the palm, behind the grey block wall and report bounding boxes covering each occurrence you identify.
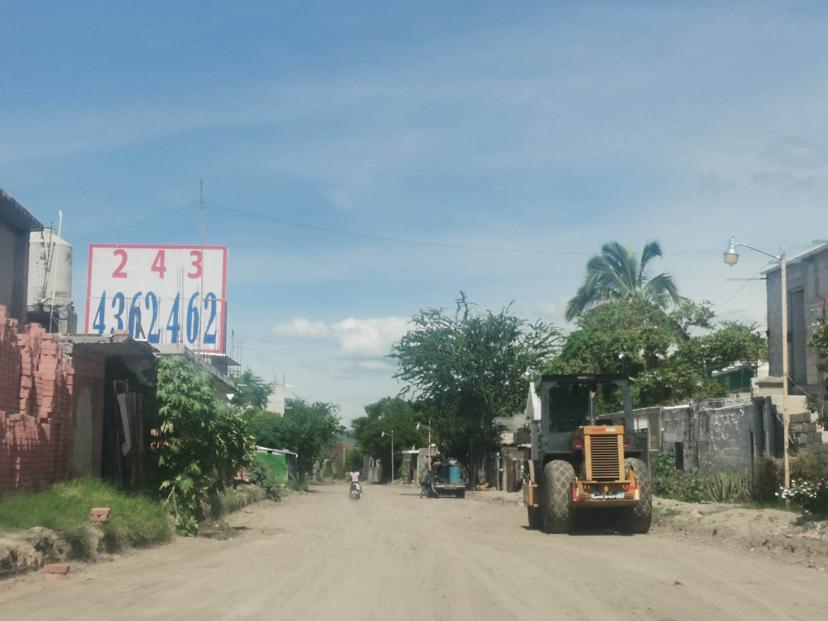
[546,299,767,407]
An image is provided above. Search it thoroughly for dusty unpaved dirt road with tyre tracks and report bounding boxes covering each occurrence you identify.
[0,485,828,621]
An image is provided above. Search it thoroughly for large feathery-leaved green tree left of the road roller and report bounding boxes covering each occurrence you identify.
[391,292,560,479]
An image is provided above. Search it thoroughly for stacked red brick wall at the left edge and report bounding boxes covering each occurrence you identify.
[0,306,73,493]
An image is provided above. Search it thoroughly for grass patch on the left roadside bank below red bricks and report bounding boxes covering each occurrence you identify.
[0,479,172,549]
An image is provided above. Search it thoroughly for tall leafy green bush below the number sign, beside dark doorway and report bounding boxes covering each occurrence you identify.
[151,357,254,535]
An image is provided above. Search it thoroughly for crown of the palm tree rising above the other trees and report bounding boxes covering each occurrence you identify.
[566,241,679,321]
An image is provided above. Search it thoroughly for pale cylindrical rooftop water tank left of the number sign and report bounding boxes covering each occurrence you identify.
[26,229,72,310]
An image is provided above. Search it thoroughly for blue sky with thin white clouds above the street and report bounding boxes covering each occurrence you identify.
[0,0,828,422]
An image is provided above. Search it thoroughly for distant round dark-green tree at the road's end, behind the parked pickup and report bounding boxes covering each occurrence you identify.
[352,397,428,477]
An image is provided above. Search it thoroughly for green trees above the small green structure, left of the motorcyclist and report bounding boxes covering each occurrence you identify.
[247,398,343,477]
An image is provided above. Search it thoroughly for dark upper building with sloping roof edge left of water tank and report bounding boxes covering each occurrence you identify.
[0,188,43,323]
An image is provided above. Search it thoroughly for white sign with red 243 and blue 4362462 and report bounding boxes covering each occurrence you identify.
[85,244,227,353]
